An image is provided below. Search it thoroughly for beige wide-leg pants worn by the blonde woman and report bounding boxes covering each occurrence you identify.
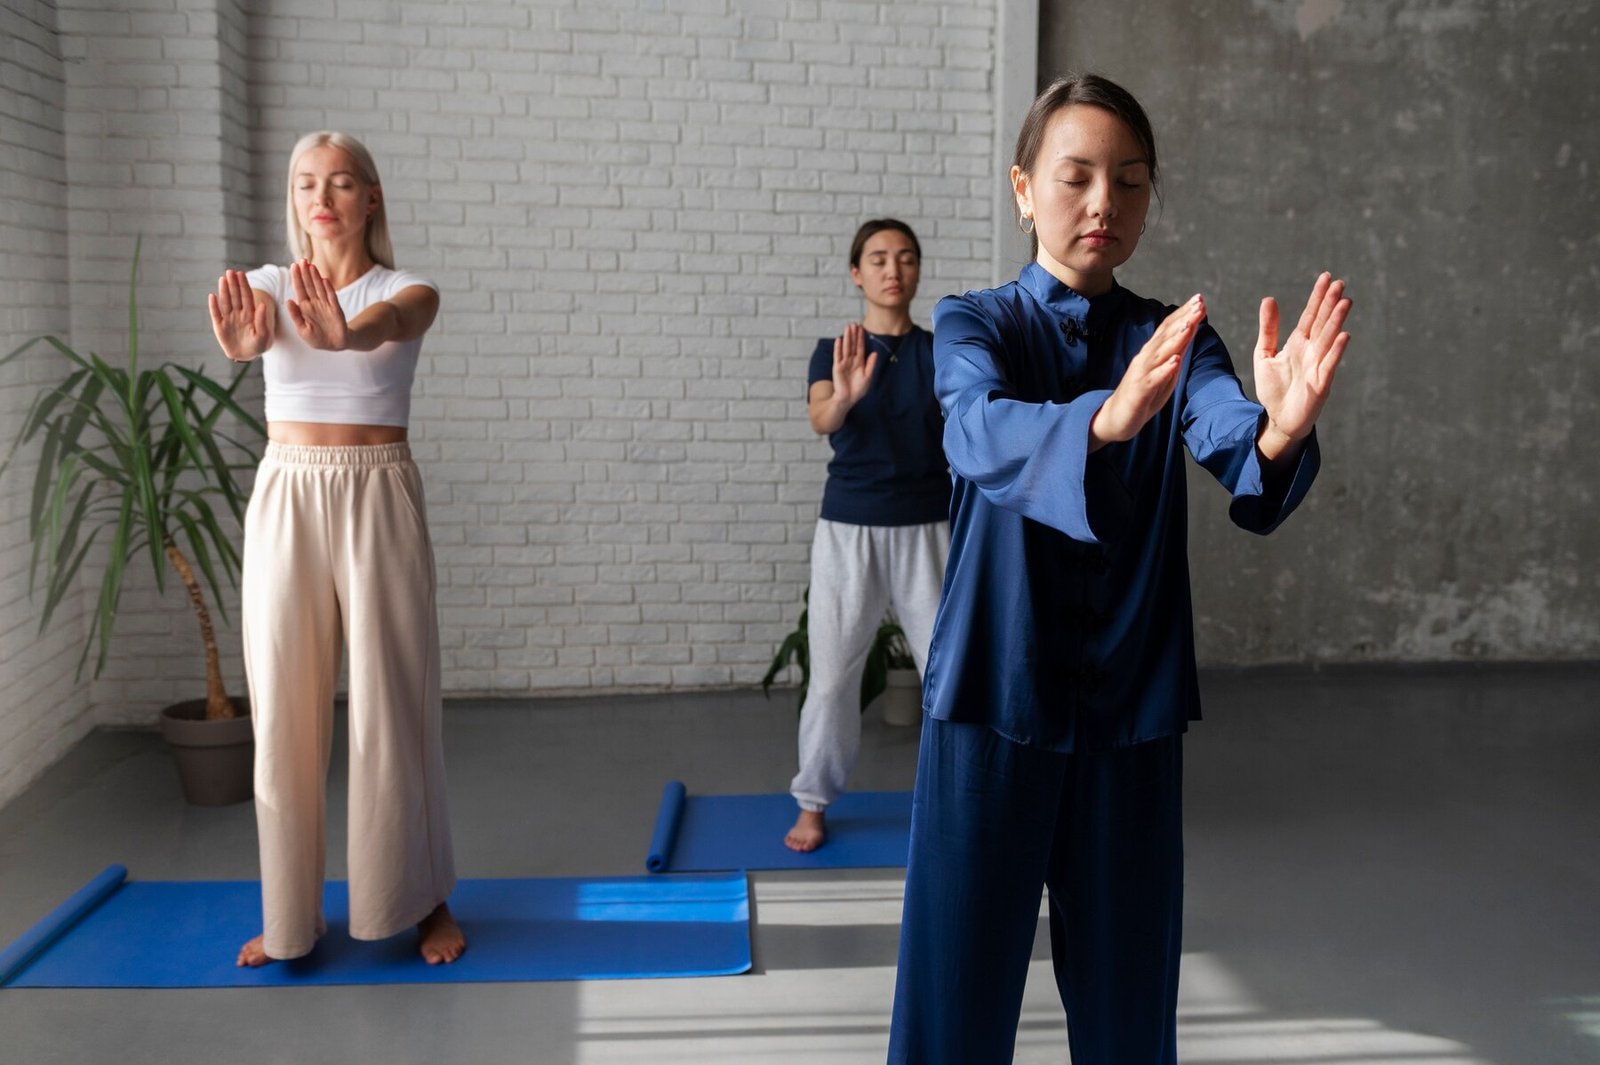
[243,443,456,958]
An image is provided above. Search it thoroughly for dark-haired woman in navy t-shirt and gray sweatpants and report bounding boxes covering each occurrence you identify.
[784,217,950,851]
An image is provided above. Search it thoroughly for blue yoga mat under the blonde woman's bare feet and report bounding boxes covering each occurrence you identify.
[0,865,750,987]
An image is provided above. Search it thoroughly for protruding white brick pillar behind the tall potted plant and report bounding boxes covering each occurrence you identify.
[61,0,254,723]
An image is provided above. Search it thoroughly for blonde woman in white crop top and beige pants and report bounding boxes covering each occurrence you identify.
[210,131,466,966]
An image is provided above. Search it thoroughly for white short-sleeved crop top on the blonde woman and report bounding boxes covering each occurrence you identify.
[245,264,438,427]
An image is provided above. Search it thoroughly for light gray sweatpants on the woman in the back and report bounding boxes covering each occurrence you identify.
[789,518,950,811]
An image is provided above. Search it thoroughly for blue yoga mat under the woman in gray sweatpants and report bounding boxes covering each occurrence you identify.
[645,780,910,873]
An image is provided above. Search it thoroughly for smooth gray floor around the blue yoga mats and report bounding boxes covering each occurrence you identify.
[0,665,1600,1065]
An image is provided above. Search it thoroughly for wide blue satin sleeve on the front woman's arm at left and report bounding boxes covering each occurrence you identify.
[933,296,1133,544]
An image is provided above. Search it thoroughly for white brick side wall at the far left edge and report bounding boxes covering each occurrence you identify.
[0,0,91,803]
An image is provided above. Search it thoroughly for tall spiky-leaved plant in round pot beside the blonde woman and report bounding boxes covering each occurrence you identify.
[0,243,266,804]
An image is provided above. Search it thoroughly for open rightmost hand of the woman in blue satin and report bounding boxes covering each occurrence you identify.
[1254,273,1350,457]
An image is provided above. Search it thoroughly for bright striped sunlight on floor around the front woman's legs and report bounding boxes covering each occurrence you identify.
[574,878,1497,1065]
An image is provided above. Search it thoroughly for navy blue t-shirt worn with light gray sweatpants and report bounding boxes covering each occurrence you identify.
[806,326,950,525]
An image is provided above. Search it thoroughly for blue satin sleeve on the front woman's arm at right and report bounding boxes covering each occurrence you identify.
[1181,316,1322,534]
